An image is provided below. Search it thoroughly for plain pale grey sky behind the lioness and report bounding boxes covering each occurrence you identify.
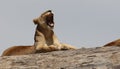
[0,0,120,53]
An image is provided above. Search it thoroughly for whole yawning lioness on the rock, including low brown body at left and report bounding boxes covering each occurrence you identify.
[2,10,76,56]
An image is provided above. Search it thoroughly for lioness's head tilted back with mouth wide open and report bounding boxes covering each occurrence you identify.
[33,10,54,29]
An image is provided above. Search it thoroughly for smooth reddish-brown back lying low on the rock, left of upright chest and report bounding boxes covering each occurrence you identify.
[2,46,35,56]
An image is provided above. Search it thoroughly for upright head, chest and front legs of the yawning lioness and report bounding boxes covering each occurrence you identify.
[33,10,75,52]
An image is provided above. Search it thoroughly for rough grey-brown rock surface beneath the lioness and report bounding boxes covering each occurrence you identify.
[0,47,120,69]
